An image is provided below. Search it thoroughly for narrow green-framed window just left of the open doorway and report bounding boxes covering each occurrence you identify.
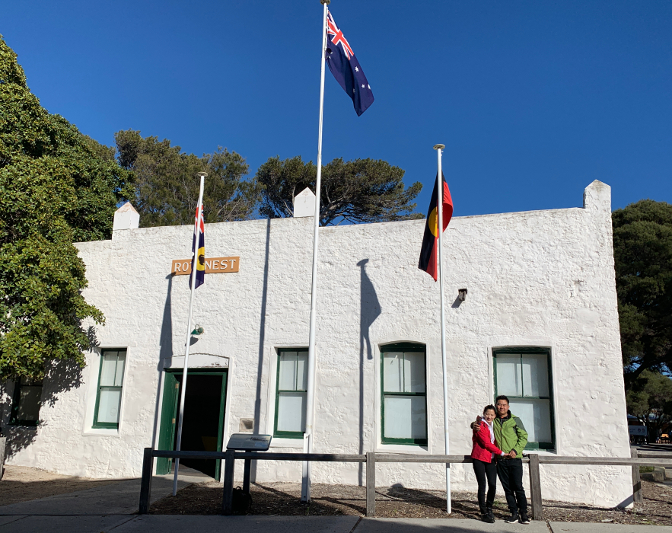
[93,350,126,429]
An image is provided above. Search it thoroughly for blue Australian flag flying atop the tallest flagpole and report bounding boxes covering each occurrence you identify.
[326,12,373,115]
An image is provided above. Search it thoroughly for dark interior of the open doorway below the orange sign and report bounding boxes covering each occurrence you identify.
[173,373,223,477]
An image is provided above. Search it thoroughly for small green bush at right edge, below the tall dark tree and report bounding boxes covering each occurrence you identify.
[626,370,672,439]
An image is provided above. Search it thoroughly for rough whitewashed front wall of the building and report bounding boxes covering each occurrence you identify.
[1,181,632,507]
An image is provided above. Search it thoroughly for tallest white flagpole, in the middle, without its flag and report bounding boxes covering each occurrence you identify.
[301,0,330,502]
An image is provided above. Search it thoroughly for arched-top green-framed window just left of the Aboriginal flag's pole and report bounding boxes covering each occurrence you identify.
[380,344,427,444]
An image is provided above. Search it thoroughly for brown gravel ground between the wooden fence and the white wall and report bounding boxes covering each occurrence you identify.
[150,481,672,525]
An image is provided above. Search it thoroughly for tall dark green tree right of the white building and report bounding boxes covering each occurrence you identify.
[612,200,672,385]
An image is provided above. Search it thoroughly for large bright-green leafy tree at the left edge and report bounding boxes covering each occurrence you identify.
[0,37,133,379]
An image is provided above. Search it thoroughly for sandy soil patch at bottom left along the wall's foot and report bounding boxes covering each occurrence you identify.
[0,465,120,506]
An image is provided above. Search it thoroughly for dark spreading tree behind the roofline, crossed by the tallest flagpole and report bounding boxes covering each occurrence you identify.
[257,156,422,226]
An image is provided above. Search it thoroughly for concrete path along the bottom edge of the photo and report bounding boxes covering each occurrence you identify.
[0,515,672,533]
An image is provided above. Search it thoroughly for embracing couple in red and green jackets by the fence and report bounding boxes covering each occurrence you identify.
[471,395,530,524]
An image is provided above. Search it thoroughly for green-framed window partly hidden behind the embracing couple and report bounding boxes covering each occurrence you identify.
[493,348,555,449]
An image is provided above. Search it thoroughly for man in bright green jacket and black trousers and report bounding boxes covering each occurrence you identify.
[471,395,530,524]
